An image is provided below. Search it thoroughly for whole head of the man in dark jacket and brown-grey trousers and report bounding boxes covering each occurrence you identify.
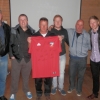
[18,14,28,30]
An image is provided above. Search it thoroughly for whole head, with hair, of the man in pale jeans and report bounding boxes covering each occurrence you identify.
[53,15,63,29]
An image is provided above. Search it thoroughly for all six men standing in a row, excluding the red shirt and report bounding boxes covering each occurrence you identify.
[0,10,100,100]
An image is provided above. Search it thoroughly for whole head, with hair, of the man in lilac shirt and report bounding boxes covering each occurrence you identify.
[89,16,99,31]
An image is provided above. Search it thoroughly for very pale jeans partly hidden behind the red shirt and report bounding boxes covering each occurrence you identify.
[52,54,66,89]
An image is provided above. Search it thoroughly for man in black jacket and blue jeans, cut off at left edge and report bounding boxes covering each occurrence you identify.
[0,10,10,100]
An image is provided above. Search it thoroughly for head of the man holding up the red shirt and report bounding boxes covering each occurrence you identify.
[39,17,48,34]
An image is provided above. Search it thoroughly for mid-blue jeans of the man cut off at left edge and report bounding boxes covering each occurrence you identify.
[0,55,8,97]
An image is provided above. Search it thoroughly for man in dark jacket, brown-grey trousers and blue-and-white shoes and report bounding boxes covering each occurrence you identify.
[9,14,34,100]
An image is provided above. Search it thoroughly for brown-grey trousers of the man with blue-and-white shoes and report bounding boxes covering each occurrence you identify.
[11,59,31,94]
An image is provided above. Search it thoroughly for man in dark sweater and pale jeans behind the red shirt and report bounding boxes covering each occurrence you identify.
[51,15,68,95]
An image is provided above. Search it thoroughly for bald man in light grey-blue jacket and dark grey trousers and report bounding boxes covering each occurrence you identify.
[67,20,91,96]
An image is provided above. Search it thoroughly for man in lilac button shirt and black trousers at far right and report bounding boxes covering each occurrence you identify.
[88,16,100,100]
